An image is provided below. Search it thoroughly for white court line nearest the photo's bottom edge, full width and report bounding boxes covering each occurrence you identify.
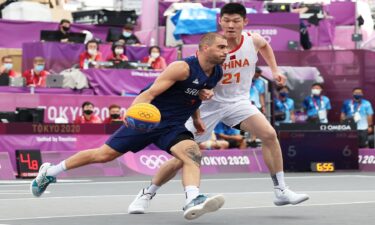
[0,201,375,221]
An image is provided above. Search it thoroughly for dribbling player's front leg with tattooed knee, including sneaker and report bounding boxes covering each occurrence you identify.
[171,140,224,220]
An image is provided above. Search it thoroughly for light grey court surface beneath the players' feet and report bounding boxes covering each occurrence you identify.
[0,172,375,225]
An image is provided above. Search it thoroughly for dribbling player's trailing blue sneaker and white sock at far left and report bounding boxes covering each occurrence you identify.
[30,163,56,197]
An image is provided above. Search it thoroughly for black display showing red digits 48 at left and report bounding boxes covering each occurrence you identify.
[16,150,42,178]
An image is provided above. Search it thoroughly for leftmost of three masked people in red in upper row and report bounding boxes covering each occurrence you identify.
[79,40,102,69]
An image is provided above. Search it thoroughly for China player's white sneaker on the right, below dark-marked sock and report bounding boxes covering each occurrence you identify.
[273,187,309,206]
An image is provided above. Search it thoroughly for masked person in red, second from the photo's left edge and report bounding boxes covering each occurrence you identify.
[22,57,49,87]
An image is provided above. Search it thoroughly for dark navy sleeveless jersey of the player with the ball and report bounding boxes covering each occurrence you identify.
[145,56,223,129]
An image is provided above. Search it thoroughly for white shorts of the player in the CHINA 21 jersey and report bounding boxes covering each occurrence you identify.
[185,100,261,143]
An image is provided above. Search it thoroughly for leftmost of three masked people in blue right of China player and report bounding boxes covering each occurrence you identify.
[274,86,295,125]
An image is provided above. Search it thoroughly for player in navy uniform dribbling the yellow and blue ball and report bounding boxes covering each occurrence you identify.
[30,33,228,219]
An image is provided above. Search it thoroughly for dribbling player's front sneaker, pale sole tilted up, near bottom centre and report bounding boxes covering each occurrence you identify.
[183,195,225,220]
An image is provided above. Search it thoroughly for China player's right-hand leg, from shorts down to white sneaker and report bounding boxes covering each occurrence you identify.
[240,113,309,206]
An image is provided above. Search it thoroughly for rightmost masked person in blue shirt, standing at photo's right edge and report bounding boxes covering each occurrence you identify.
[340,87,374,148]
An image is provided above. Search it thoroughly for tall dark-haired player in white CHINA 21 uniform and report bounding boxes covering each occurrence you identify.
[128,3,309,213]
